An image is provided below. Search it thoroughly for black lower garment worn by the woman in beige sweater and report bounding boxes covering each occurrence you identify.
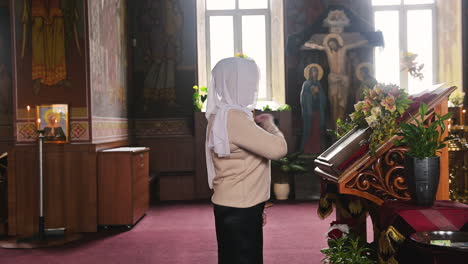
[213,203,265,264]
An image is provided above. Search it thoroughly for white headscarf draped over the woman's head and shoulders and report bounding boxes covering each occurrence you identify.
[205,57,260,189]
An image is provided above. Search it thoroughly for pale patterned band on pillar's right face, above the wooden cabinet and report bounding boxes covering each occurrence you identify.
[92,117,129,143]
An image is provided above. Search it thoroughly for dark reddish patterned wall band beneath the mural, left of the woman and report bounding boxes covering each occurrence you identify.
[133,118,193,138]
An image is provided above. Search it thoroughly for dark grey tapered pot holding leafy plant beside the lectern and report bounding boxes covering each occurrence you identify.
[405,157,440,206]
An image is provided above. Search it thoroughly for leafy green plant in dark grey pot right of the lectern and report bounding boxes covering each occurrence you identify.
[394,103,452,206]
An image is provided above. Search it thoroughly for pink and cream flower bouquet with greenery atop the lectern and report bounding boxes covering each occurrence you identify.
[350,83,412,155]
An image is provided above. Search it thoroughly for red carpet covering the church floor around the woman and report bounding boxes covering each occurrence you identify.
[0,202,344,264]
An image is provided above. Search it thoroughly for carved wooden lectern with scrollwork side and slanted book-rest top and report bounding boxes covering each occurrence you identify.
[315,87,456,205]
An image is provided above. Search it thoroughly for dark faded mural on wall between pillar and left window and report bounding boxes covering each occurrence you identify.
[130,0,197,119]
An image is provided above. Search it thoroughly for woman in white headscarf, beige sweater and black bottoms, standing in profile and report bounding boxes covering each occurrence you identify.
[206,57,287,264]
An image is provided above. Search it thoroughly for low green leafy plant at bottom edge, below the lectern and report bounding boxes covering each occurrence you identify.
[320,236,376,264]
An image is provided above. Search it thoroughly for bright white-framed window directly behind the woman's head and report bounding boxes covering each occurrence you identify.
[197,0,285,104]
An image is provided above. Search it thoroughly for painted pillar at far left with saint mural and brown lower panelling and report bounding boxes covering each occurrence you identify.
[8,0,128,236]
